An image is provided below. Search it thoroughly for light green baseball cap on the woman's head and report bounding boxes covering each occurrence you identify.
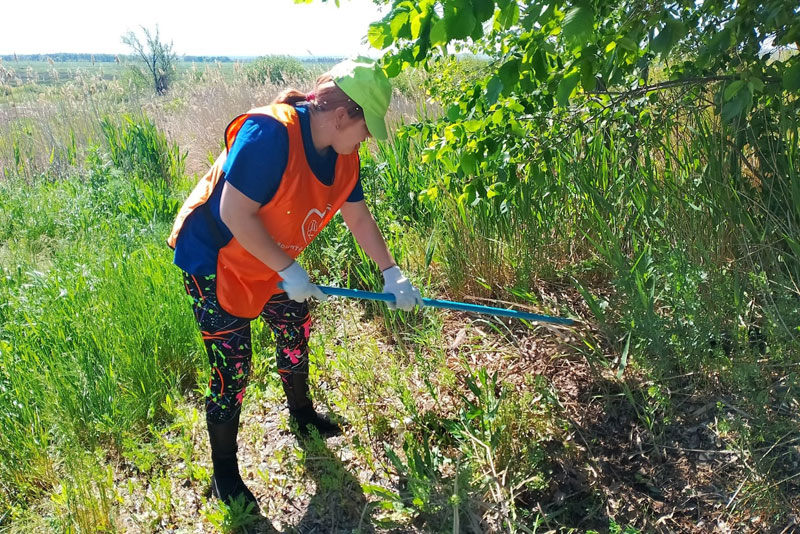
[330,56,392,139]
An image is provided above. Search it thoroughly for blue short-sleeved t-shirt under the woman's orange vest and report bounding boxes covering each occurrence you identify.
[174,106,364,275]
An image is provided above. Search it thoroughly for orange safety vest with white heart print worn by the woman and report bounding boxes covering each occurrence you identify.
[167,104,359,318]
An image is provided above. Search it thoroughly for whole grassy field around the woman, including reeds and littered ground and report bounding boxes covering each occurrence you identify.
[0,58,800,534]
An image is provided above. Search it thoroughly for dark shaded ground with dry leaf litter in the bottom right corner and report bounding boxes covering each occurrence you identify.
[518,372,800,534]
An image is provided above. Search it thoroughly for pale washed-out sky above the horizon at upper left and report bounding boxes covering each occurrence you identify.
[0,0,381,56]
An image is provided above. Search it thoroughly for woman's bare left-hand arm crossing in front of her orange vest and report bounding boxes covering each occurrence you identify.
[219,182,294,272]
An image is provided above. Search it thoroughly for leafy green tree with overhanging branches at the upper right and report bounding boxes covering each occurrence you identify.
[368,0,800,273]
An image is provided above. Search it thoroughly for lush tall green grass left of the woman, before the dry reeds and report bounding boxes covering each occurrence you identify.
[0,114,202,528]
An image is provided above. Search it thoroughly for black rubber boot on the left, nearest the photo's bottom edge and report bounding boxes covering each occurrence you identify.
[206,413,259,513]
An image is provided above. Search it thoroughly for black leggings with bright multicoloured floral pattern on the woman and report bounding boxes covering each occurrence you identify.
[183,272,311,424]
